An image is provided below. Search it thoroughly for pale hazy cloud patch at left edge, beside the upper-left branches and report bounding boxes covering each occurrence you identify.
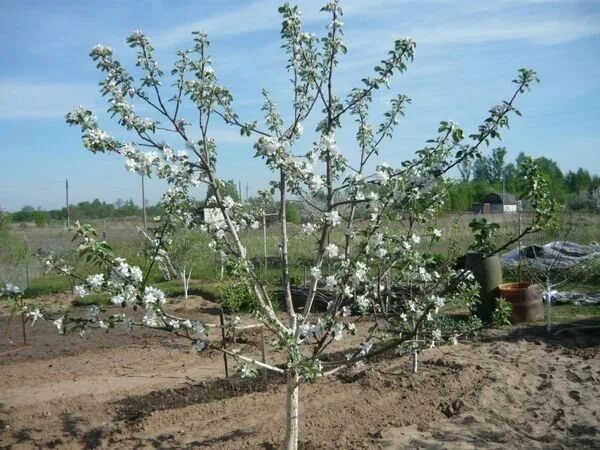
[0,79,96,119]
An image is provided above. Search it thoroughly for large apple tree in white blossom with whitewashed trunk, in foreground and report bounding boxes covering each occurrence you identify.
[3,1,548,449]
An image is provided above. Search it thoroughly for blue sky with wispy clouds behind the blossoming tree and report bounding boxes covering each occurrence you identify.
[0,0,600,211]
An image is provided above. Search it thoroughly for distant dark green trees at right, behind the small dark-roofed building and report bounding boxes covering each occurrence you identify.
[447,147,600,211]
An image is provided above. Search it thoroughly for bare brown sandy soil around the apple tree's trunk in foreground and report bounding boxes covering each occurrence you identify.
[0,299,600,449]
